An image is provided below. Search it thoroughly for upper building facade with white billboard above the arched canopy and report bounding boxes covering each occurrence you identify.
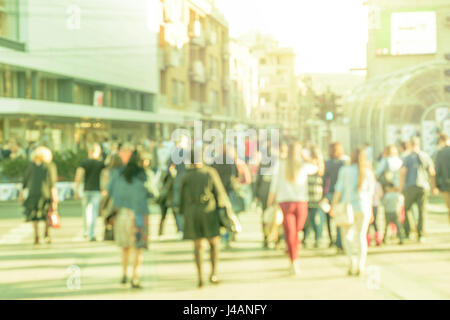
[367,0,450,79]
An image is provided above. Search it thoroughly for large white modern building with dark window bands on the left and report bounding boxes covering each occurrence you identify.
[0,0,171,149]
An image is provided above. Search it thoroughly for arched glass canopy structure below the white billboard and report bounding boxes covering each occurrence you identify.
[344,60,450,155]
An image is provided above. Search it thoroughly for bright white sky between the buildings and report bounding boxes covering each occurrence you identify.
[216,0,367,73]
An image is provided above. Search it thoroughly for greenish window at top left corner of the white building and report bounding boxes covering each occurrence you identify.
[0,0,19,41]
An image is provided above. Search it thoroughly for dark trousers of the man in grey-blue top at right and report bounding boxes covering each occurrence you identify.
[404,186,427,237]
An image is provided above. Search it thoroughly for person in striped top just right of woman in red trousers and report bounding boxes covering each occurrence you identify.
[303,146,326,248]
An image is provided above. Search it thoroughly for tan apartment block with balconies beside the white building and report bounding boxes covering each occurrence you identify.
[159,0,231,131]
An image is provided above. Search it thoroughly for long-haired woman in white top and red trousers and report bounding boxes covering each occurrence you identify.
[268,142,318,274]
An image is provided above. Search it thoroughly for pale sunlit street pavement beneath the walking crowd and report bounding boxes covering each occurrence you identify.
[0,198,450,300]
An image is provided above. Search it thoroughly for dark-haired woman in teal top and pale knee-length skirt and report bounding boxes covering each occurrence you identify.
[107,151,150,289]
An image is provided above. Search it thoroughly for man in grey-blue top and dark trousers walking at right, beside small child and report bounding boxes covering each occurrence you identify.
[399,137,436,243]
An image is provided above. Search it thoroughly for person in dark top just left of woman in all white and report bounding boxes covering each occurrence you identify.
[323,142,348,250]
